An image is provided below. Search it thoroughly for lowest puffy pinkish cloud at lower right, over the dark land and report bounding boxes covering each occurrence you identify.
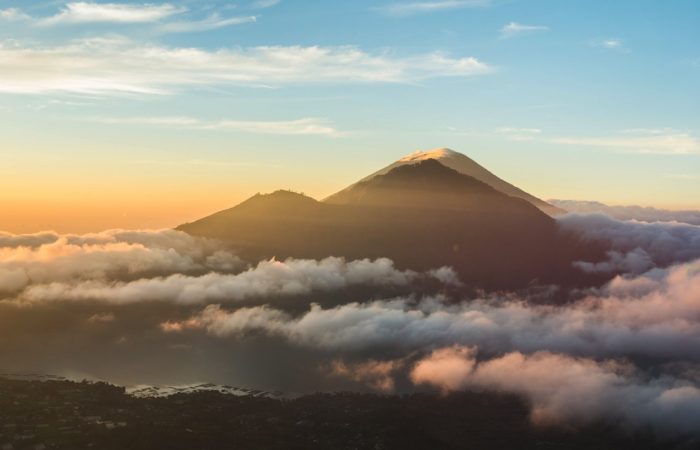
[411,347,700,435]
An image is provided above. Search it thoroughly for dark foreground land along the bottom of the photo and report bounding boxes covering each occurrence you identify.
[0,379,694,450]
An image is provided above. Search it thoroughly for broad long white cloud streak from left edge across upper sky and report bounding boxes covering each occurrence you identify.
[0,38,492,95]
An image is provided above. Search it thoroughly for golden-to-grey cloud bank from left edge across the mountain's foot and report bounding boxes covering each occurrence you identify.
[0,230,461,304]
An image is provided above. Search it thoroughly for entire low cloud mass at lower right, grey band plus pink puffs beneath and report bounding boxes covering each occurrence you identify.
[161,251,700,436]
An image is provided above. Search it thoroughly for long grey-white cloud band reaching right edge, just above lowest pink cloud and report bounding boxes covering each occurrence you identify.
[164,261,700,362]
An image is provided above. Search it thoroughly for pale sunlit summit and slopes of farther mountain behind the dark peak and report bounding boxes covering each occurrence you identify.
[324,148,566,215]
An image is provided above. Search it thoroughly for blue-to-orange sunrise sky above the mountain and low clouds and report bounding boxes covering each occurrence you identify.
[0,0,700,229]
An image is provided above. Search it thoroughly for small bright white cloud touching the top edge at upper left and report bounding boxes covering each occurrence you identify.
[38,2,186,25]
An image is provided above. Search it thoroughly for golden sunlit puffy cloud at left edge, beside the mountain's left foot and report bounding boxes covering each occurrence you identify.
[0,230,242,292]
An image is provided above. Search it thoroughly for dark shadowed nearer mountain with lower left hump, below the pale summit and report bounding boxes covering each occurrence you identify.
[179,153,592,289]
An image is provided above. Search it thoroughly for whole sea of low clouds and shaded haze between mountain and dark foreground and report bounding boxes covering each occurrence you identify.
[0,214,700,435]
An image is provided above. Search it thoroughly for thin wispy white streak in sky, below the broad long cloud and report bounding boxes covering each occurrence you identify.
[88,116,348,137]
